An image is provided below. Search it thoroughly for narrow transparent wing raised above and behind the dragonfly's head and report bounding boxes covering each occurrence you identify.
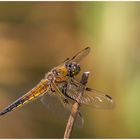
[65,47,90,63]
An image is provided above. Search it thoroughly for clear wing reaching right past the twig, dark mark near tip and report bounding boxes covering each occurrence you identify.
[66,79,114,109]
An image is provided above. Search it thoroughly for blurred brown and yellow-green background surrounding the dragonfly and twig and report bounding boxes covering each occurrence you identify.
[0,2,140,138]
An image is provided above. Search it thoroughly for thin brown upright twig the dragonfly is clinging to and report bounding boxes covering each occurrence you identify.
[64,72,89,139]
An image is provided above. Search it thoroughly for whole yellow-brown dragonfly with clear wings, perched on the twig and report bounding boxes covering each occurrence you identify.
[0,47,114,127]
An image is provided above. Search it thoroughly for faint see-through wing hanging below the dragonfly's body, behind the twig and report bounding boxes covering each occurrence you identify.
[41,92,84,128]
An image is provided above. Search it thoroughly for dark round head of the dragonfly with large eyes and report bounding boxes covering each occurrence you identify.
[66,62,80,77]
